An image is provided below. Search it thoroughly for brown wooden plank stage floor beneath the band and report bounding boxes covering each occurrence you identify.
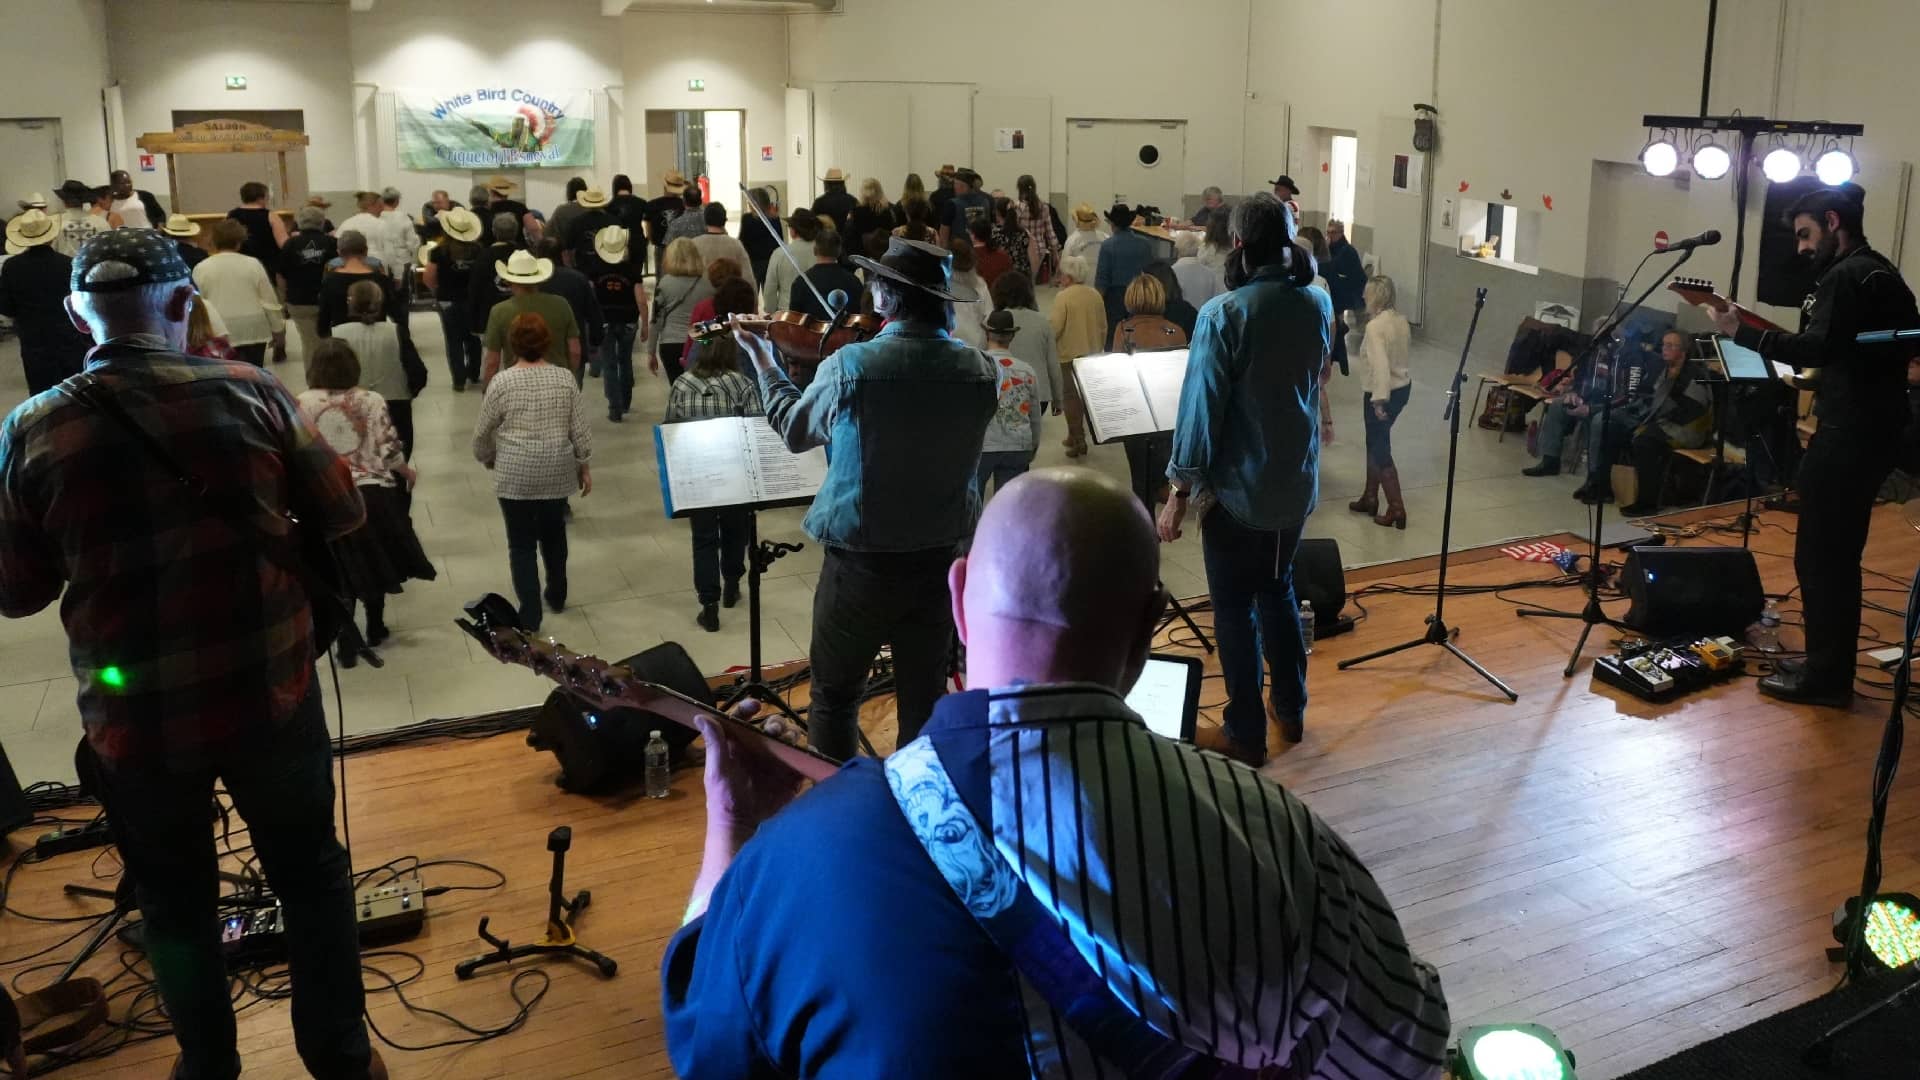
[11,505,1920,1080]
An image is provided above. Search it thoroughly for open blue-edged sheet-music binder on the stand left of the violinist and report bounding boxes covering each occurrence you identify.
[653,417,828,517]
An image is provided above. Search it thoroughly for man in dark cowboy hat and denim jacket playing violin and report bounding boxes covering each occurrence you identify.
[735,238,998,759]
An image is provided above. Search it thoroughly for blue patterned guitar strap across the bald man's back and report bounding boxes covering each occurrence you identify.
[885,690,1273,1080]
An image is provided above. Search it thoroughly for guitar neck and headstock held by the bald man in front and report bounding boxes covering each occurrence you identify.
[453,594,841,782]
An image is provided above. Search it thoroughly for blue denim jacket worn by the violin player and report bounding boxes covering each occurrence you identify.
[760,323,998,552]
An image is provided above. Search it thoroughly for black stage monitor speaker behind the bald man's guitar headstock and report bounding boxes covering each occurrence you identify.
[526,642,714,792]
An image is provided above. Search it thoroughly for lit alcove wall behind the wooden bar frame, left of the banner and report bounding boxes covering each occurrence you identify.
[107,0,353,197]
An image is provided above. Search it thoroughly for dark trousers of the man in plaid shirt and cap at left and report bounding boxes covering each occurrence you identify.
[96,676,372,1080]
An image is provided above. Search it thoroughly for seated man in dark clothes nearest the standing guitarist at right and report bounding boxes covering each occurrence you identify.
[1574,331,1713,515]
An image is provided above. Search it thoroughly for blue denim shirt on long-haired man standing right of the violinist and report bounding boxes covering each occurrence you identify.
[1167,267,1332,528]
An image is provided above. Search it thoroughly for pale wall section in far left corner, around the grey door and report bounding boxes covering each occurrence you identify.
[0,0,111,182]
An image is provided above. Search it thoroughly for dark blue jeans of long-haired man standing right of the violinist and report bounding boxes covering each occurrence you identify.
[1200,505,1308,751]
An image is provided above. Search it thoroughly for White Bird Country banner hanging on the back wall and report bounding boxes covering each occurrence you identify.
[394,85,593,169]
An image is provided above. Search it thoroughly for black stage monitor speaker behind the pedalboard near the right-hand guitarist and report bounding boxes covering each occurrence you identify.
[1620,546,1766,638]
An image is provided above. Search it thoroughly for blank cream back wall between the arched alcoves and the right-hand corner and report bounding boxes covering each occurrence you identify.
[789,0,1271,194]
